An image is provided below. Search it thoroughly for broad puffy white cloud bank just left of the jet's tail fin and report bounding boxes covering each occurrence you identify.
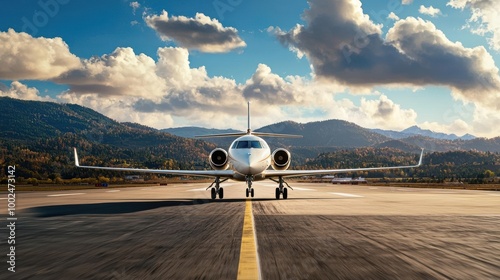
[57,47,245,128]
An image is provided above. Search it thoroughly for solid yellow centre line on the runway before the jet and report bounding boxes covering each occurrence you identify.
[237,199,261,279]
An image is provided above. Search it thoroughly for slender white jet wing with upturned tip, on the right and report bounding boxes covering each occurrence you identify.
[264,149,424,178]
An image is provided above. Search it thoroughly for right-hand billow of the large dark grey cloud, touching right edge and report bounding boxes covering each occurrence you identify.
[387,17,500,109]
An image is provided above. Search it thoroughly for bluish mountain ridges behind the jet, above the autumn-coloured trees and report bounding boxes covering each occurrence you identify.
[0,97,500,152]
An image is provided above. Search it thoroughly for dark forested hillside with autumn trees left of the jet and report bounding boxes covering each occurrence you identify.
[0,98,215,179]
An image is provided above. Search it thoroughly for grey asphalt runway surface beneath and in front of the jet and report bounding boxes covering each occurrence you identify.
[0,181,500,279]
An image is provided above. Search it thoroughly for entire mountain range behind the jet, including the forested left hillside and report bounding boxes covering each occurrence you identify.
[0,97,500,178]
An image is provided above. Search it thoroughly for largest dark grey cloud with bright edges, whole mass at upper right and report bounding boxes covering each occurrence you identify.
[275,0,500,109]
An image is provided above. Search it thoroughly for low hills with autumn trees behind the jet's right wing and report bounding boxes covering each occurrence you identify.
[301,147,500,181]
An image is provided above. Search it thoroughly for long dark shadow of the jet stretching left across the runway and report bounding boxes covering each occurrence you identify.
[26,198,334,218]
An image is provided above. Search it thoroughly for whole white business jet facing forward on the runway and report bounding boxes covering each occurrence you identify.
[74,102,424,199]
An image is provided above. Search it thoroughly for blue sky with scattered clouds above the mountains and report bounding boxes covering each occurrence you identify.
[0,0,500,137]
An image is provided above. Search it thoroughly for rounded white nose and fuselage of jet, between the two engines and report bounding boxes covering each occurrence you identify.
[228,135,271,180]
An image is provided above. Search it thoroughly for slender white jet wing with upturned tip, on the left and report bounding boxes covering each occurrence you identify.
[74,148,234,178]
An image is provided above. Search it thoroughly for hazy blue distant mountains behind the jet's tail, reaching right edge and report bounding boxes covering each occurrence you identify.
[162,120,500,152]
